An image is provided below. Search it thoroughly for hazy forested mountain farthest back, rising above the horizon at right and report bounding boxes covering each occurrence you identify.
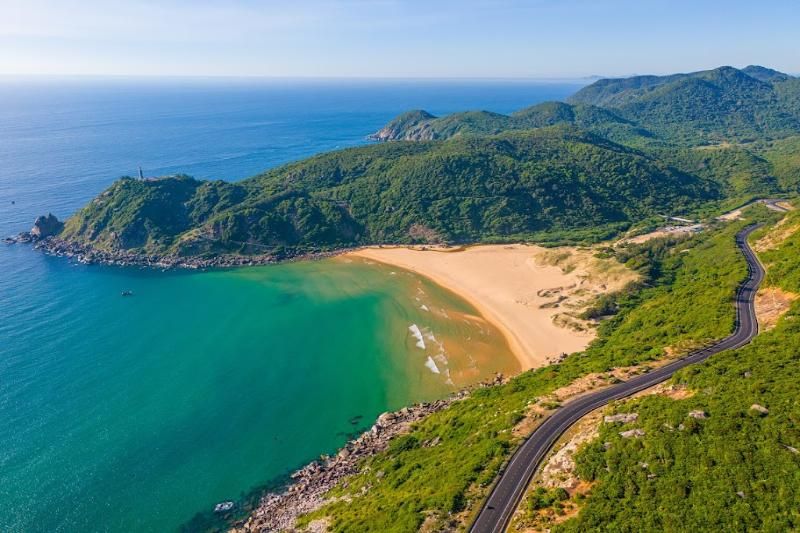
[568,66,800,144]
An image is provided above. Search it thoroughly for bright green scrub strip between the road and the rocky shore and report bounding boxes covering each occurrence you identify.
[296,218,746,532]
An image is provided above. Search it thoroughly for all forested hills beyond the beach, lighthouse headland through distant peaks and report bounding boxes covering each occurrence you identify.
[54,67,800,258]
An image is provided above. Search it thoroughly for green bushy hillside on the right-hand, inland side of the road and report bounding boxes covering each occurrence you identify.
[554,213,800,531]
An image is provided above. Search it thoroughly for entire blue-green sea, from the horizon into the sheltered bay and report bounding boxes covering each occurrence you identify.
[0,78,579,532]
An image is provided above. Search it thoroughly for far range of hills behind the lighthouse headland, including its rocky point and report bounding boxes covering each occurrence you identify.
[375,66,800,147]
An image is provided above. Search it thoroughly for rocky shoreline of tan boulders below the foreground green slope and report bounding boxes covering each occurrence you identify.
[231,374,504,533]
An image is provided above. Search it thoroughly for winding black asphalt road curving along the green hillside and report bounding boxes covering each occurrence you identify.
[470,225,764,533]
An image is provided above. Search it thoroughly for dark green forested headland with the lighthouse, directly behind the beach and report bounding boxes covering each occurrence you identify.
[61,127,721,256]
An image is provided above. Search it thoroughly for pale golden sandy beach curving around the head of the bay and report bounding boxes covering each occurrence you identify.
[347,244,636,369]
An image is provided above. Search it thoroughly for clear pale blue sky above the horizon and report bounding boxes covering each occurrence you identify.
[0,0,800,78]
